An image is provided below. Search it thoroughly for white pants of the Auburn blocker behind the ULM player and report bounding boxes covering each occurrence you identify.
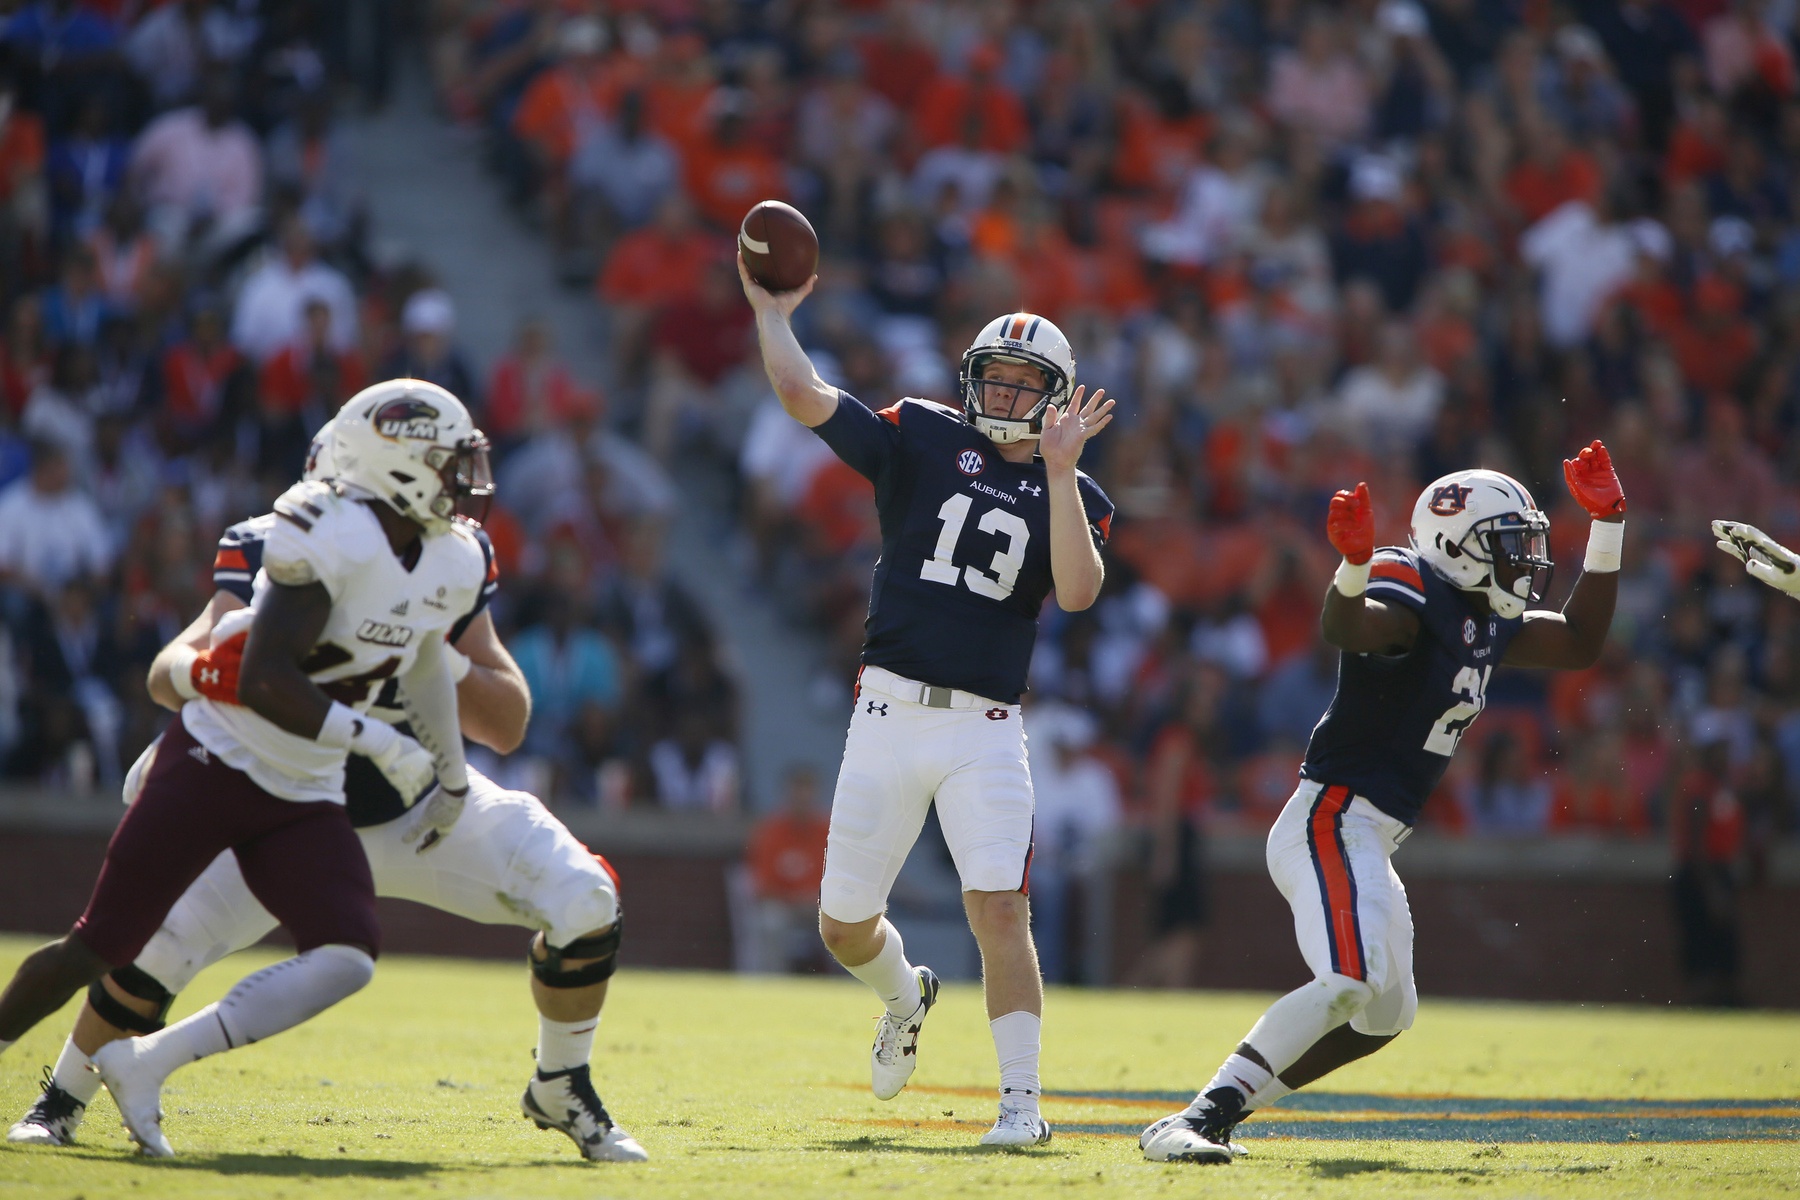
[137,768,619,991]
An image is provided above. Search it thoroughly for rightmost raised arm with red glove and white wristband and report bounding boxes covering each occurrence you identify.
[1501,441,1625,671]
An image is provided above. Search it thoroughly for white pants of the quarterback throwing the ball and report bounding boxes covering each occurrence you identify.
[819,669,1033,923]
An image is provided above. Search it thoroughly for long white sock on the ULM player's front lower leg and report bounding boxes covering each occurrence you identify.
[139,946,374,1074]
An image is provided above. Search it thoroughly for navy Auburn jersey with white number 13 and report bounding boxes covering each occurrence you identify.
[814,392,1112,703]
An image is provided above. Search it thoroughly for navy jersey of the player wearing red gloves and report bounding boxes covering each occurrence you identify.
[1300,547,1525,824]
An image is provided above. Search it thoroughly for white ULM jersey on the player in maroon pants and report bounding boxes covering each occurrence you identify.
[182,482,488,804]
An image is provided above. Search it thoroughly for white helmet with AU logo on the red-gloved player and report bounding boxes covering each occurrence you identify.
[1413,470,1552,619]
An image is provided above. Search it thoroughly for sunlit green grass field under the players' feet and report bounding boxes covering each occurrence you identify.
[0,939,1800,1200]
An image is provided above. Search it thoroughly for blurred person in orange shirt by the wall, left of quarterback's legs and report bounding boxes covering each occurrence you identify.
[743,766,830,973]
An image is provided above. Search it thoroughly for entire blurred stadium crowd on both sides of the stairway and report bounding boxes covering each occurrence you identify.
[0,0,1800,949]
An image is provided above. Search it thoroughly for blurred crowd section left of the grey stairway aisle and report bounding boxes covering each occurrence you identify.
[0,0,738,810]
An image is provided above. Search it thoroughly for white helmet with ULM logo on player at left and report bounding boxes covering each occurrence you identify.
[329,380,493,534]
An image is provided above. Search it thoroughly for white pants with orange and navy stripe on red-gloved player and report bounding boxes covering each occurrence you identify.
[1269,779,1418,1036]
